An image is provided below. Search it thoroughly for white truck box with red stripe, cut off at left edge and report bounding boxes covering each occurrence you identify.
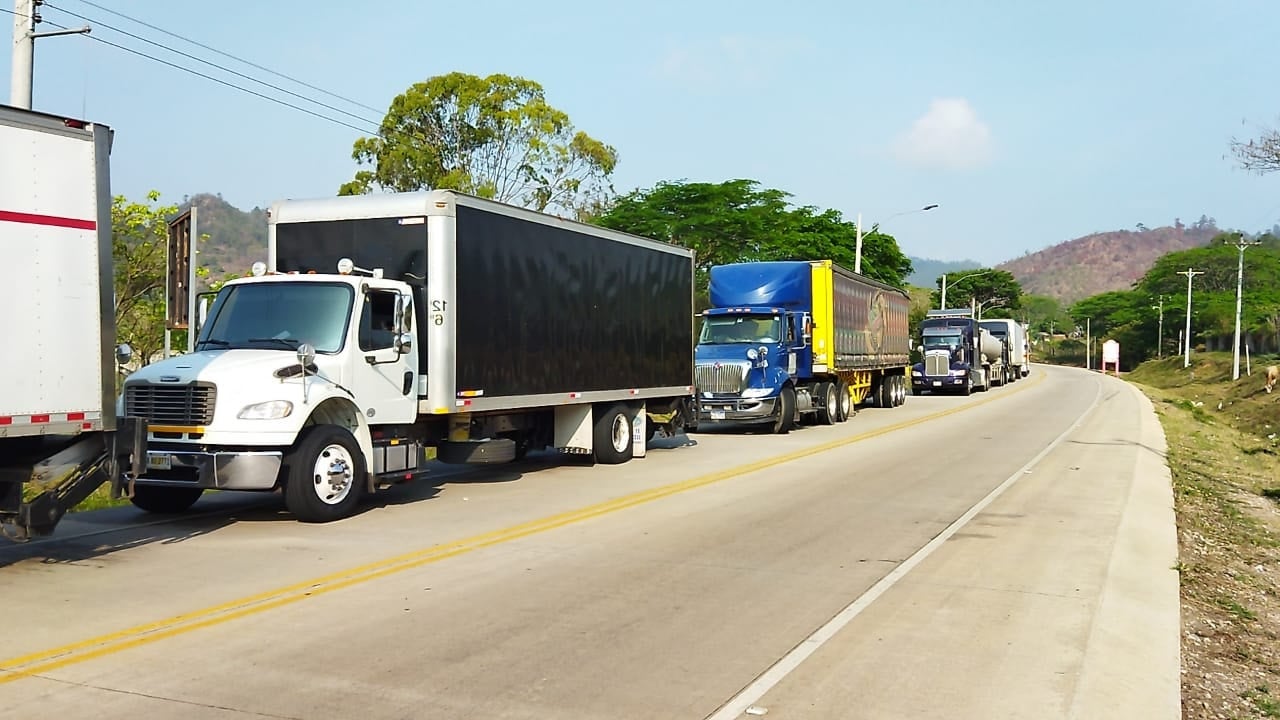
[0,105,145,539]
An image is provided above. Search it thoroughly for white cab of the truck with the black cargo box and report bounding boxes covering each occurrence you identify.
[120,261,420,521]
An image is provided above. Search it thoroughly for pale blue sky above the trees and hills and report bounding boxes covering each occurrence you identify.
[0,0,1280,264]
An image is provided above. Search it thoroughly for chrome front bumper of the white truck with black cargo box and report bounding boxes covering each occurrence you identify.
[137,448,284,489]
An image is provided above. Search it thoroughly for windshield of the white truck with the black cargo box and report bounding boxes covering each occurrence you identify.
[196,282,355,352]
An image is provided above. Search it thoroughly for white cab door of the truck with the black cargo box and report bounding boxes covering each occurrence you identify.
[351,288,419,424]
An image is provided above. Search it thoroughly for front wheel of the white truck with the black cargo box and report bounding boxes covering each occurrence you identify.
[284,425,365,523]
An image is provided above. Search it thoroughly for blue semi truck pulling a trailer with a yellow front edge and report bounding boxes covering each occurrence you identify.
[694,260,910,433]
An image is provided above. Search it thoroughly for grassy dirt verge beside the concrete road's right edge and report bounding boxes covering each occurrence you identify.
[1126,354,1280,719]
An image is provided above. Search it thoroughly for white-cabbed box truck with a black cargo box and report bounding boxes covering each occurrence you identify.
[120,191,694,521]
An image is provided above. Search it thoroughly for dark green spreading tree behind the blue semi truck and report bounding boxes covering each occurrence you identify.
[594,179,911,287]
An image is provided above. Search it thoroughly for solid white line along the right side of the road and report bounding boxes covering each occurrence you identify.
[707,368,1102,720]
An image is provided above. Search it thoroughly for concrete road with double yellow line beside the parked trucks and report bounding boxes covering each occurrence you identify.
[0,366,1178,720]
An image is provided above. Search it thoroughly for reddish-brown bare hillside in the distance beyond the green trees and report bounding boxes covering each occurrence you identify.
[997,217,1220,304]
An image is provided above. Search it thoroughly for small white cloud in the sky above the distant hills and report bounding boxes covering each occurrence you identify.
[893,97,991,170]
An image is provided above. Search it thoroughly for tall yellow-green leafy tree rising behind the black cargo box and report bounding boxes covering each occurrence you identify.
[338,72,618,215]
